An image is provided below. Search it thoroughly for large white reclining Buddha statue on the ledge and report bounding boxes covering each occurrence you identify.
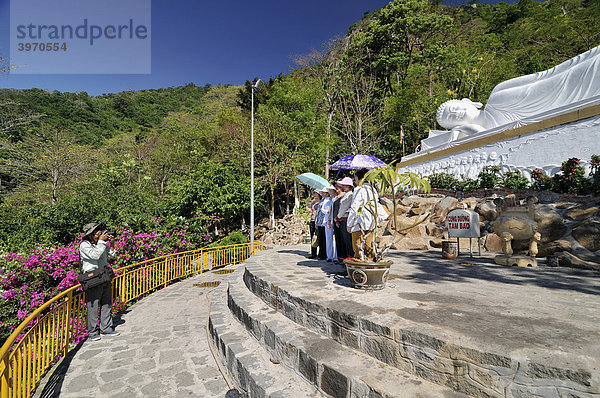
[436,46,600,140]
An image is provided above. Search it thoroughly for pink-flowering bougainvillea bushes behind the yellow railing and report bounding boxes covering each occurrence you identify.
[0,216,219,345]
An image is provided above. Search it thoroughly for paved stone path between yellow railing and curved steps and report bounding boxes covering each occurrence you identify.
[36,266,234,398]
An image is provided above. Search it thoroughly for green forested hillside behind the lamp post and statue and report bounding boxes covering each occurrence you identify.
[0,0,600,249]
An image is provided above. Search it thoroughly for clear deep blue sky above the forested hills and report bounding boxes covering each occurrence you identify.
[0,0,514,95]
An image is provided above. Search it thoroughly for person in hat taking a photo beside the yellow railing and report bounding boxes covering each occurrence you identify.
[79,223,119,341]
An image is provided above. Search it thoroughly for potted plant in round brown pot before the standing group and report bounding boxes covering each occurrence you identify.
[344,166,431,290]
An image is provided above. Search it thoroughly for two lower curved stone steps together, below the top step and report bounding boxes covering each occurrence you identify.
[209,268,466,398]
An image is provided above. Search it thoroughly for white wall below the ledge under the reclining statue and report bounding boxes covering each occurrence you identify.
[401,115,600,180]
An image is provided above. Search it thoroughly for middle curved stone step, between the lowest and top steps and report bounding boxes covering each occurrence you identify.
[228,274,466,398]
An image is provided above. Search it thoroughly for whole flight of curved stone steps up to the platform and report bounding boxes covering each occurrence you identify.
[209,250,598,398]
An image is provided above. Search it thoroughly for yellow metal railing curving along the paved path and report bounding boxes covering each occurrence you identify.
[0,241,263,398]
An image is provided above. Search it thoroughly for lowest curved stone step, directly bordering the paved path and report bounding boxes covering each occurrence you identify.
[209,268,323,398]
